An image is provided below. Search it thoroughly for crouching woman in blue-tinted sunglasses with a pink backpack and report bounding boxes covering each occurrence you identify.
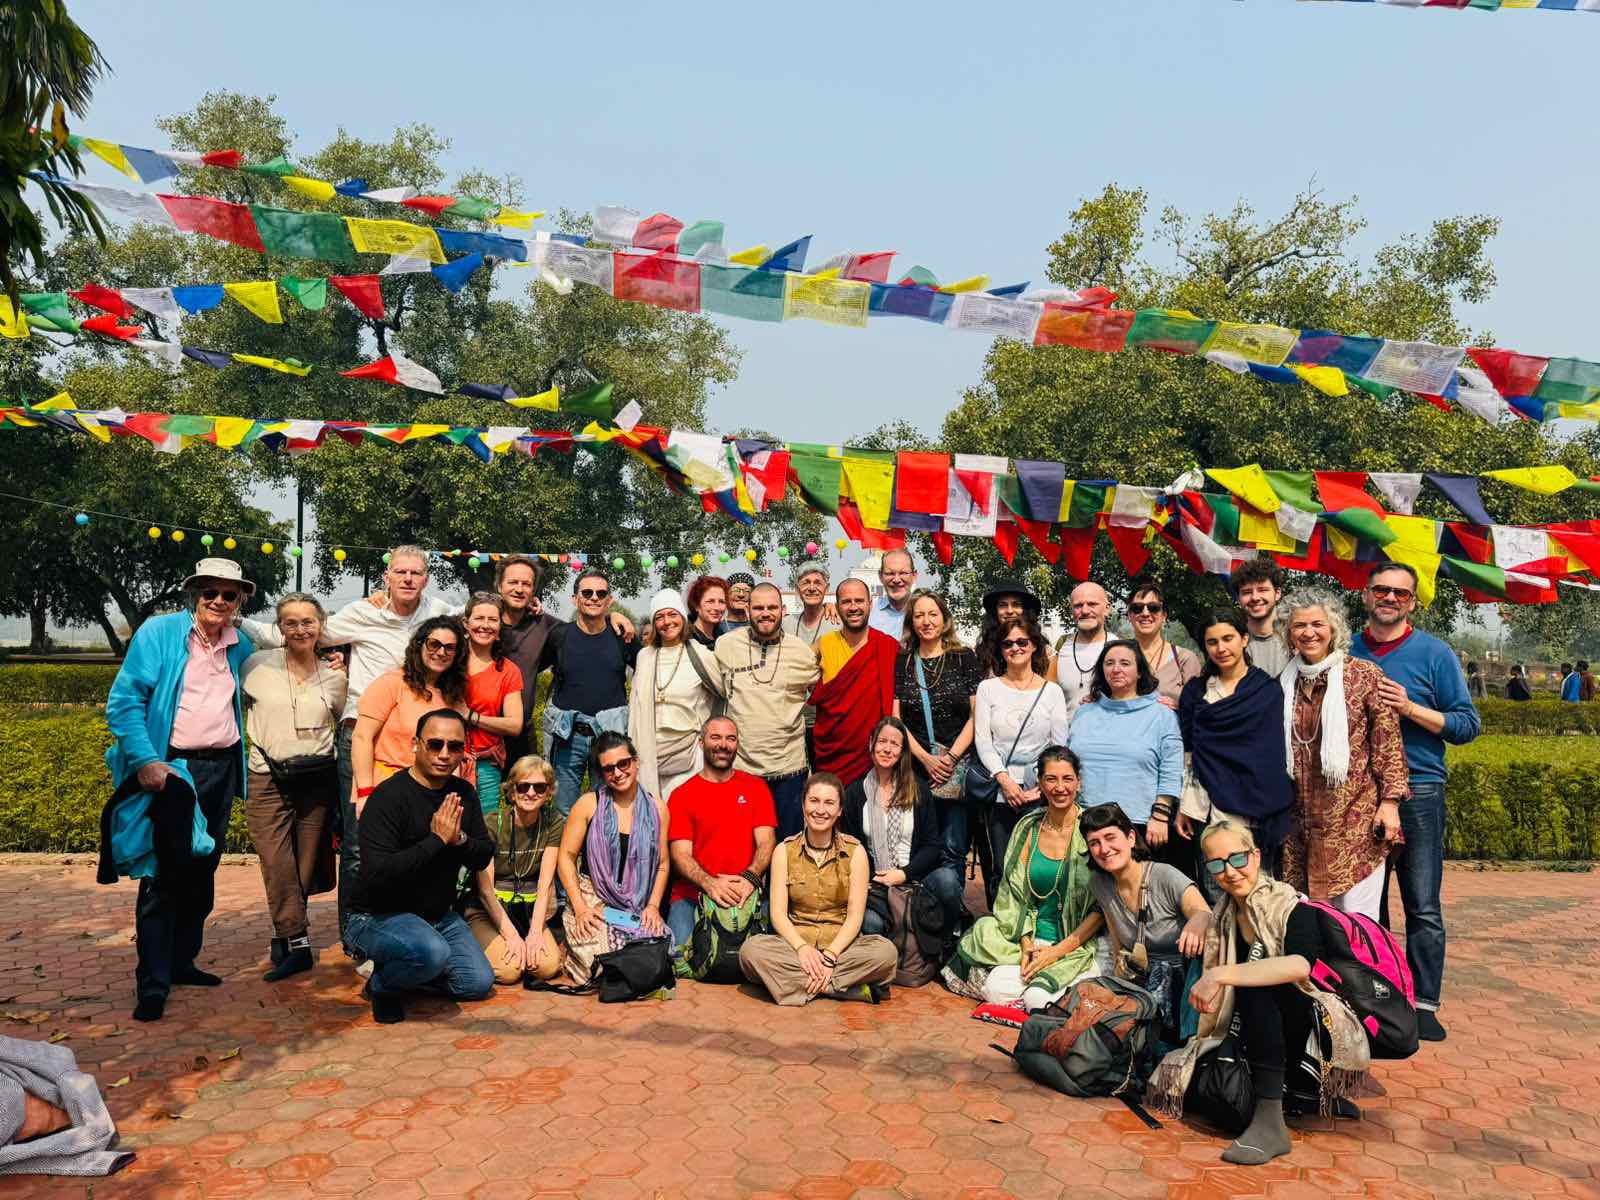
[1146,821,1371,1166]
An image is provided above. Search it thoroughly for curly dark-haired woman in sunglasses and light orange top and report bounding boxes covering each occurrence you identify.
[350,616,467,816]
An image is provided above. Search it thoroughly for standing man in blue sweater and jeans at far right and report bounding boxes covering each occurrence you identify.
[1350,563,1483,1042]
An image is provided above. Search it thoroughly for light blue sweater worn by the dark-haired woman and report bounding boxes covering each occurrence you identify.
[1067,691,1184,826]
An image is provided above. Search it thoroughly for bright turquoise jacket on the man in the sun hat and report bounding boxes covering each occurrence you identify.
[106,613,254,878]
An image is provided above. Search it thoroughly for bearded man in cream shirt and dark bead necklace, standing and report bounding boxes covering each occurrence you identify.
[717,582,822,837]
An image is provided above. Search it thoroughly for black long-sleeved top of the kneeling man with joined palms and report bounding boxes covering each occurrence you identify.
[350,771,494,922]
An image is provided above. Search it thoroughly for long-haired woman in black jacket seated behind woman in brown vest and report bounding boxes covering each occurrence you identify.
[842,717,963,960]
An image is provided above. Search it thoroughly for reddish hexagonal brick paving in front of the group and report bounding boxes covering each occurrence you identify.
[0,858,1600,1200]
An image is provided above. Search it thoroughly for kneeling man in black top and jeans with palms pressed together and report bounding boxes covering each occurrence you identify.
[347,709,494,1024]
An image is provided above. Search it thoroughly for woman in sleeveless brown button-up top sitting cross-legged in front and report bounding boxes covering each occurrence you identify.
[739,771,899,1006]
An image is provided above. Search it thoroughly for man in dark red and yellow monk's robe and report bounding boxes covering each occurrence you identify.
[812,579,899,790]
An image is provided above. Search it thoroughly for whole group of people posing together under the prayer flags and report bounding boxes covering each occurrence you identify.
[102,546,1478,1160]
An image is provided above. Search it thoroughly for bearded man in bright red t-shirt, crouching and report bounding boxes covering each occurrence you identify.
[667,717,778,947]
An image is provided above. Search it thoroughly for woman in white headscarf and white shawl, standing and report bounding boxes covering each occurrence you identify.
[627,587,722,802]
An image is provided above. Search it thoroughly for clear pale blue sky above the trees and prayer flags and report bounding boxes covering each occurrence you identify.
[72,0,1600,440]
